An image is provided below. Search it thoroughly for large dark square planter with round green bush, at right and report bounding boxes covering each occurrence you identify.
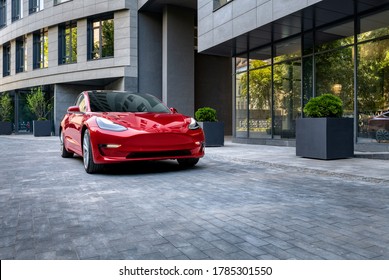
[296,94,354,159]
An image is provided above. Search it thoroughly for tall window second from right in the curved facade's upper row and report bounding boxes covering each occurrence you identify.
[58,22,77,64]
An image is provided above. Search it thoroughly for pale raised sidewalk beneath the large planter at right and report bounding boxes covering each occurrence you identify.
[206,139,389,183]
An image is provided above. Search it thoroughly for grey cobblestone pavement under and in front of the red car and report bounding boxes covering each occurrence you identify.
[0,135,389,260]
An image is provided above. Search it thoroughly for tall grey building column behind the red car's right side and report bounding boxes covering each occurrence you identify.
[162,6,195,116]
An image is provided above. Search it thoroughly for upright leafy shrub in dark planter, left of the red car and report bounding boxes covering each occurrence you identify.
[27,87,52,136]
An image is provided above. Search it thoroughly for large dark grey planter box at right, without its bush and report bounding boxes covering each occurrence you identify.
[296,118,354,159]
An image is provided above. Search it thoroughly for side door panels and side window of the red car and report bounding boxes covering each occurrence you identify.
[66,93,86,155]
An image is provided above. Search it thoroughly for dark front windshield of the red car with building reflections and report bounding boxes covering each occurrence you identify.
[88,91,170,113]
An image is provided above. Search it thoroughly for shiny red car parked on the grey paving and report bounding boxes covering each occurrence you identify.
[59,91,204,173]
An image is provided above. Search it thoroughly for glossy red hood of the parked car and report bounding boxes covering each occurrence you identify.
[101,113,190,133]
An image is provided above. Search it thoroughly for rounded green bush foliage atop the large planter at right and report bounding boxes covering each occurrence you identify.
[304,93,343,118]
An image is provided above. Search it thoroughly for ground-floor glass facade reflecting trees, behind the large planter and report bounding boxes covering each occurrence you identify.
[234,7,389,143]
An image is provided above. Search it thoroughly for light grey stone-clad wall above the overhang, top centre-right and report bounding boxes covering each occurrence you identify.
[197,0,322,52]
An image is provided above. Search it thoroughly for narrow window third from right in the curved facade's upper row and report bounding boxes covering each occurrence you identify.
[33,28,49,69]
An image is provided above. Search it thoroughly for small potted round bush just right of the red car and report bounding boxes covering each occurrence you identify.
[195,107,224,147]
